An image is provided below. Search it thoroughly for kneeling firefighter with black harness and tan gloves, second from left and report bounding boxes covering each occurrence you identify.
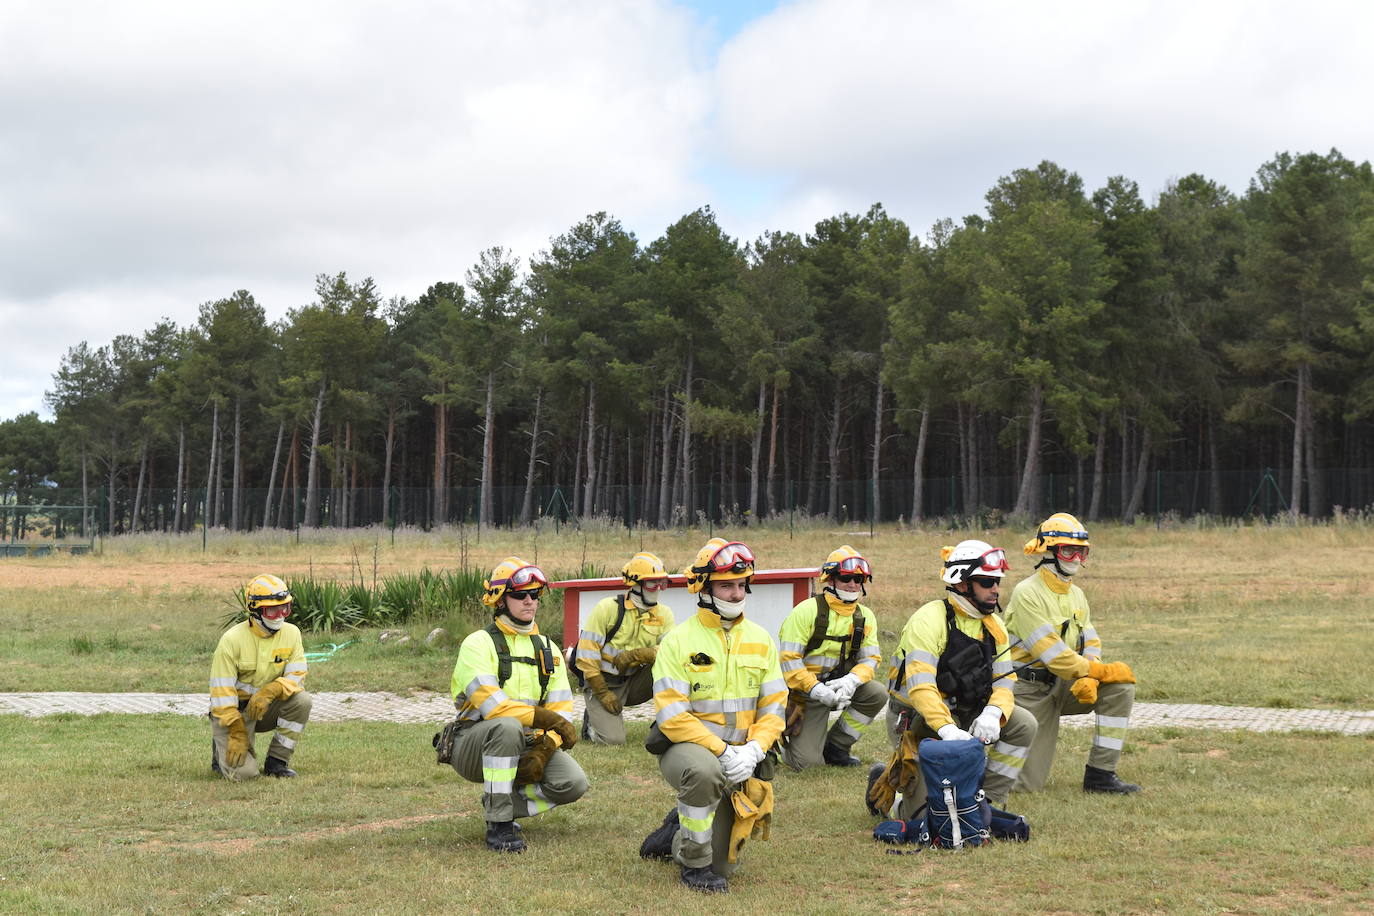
[449,556,587,853]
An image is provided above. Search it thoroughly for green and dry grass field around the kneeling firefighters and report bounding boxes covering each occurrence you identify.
[0,525,1374,913]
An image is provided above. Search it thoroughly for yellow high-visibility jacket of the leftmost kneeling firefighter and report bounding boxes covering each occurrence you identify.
[210,619,305,728]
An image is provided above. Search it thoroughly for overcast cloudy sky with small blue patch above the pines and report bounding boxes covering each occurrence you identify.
[0,0,1374,419]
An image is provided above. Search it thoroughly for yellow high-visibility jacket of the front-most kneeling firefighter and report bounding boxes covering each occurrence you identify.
[654,608,787,757]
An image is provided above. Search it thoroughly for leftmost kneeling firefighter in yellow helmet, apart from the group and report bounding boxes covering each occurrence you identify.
[210,575,311,780]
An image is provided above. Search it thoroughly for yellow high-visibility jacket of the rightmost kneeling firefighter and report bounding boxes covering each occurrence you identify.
[1006,566,1102,681]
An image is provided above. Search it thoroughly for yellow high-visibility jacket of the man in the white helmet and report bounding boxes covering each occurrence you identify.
[888,600,1017,732]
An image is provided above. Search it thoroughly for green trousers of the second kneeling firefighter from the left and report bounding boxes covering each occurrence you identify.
[452,715,587,821]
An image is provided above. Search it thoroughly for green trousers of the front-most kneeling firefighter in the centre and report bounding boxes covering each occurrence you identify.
[658,742,775,878]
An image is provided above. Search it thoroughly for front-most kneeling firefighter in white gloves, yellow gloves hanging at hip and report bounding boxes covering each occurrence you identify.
[639,537,787,893]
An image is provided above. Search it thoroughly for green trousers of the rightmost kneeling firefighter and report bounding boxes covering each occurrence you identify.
[1015,677,1135,792]
